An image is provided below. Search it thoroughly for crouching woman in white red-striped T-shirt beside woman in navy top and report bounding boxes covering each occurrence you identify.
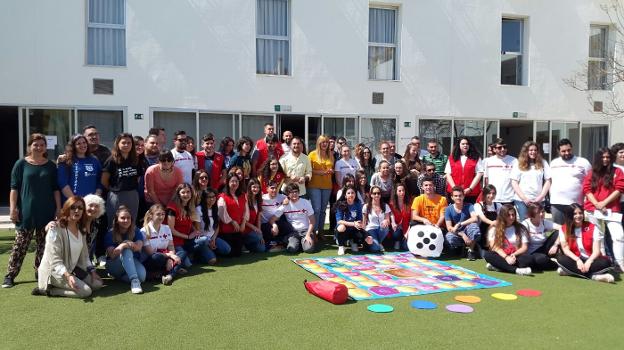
[141,204,186,286]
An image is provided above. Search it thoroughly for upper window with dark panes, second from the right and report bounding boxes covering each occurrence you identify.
[501,18,525,85]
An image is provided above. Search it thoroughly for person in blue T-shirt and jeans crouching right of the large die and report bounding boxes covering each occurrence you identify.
[444,186,481,261]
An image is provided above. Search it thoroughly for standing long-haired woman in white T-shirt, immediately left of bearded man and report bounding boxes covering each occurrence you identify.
[510,141,551,221]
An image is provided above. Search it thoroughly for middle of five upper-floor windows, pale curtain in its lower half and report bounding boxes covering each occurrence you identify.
[368,7,398,80]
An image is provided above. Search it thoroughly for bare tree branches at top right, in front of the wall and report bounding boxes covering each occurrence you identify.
[564,0,624,117]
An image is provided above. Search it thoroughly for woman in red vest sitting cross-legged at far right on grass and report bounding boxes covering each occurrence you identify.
[557,203,614,283]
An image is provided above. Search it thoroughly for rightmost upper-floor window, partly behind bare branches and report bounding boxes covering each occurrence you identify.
[587,25,609,90]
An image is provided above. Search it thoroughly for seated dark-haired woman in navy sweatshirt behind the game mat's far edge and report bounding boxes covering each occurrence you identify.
[335,185,366,255]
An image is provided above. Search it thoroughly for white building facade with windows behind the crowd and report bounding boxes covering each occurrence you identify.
[0,0,624,176]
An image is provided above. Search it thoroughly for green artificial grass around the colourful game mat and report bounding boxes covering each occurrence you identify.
[0,230,624,349]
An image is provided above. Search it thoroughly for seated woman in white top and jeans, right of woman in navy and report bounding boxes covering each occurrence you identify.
[362,186,391,253]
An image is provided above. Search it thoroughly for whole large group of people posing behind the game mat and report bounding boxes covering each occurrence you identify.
[2,123,624,298]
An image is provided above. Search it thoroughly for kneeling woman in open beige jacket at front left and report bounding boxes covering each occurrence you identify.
[33,196,102,298]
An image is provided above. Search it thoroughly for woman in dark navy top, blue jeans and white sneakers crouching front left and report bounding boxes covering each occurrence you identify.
[104,205,145,294]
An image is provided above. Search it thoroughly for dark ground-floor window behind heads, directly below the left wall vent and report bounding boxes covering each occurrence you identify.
[77,110,122,148]
